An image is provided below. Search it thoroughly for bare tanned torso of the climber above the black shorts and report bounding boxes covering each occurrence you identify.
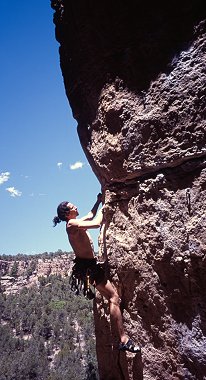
[66,223,94,259]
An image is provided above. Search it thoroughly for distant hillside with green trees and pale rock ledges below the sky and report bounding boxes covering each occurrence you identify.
[0,251,98,380]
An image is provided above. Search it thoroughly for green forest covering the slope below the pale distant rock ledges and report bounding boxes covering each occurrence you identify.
[0,268,98,380]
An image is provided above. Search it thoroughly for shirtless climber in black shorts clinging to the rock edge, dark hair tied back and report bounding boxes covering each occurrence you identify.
[53,194,141,353]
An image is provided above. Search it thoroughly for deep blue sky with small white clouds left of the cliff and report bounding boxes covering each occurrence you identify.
[0,0,100,254]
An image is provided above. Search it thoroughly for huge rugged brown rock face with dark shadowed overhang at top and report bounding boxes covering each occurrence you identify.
[52,0,206,380]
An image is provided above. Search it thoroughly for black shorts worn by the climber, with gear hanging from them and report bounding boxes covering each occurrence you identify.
[72,257,106,285]
